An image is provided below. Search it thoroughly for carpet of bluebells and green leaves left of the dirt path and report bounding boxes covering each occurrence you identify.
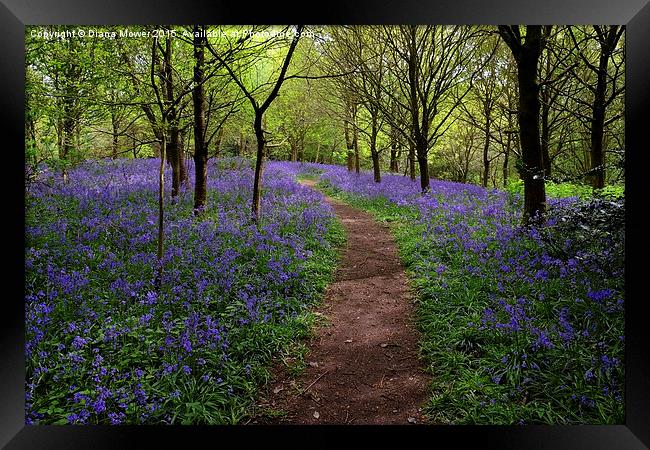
[25,159,343,424]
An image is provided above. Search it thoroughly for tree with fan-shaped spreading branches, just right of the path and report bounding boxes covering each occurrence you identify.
[376,25,479,192]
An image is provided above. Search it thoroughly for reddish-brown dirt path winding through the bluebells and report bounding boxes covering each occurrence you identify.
[251,182,428,424]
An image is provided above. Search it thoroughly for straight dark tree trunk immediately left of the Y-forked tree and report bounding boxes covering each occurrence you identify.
[192,25,208,215]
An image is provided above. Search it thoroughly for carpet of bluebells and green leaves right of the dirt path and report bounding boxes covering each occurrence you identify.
[314,165,625,424]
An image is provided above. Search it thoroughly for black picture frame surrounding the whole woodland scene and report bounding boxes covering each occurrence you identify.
[0,0,650,449]
